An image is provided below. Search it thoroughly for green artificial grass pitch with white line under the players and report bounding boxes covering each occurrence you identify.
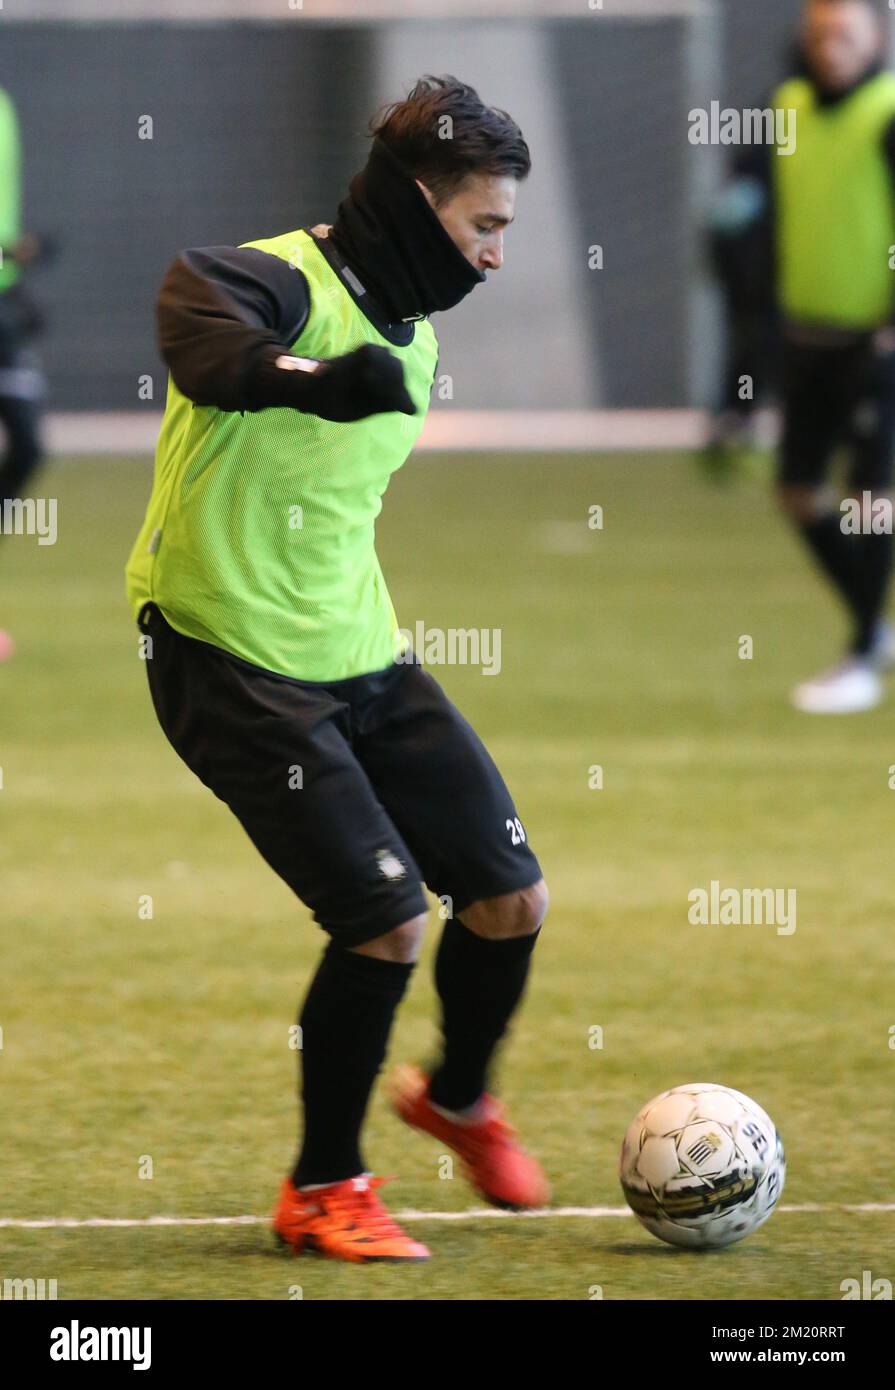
[0,455,895,1300]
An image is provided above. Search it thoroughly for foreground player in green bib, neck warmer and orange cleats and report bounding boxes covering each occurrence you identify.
[128,76,549,1261]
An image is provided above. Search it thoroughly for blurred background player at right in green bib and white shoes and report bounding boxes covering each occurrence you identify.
[766,0,895,714]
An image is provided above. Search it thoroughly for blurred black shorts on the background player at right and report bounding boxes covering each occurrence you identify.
[780,335,895,492]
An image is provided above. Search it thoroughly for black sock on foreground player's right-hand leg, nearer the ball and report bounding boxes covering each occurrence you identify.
[429,917,538,1111]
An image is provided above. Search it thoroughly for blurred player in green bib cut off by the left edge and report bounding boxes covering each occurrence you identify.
[0,89,44,662]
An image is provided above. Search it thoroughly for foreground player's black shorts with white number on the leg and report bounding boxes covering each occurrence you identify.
[140,603,541,947]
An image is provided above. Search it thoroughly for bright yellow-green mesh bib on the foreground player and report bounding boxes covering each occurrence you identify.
[128,231,438,681]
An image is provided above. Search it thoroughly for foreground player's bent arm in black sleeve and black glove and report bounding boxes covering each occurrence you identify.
[157,246,416,421]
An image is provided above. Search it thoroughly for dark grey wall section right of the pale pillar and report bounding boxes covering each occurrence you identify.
[553,19,691,407]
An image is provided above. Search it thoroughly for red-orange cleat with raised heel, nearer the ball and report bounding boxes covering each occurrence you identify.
[391,1066,550,1211]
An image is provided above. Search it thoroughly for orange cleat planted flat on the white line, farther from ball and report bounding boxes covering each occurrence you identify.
[274,1175,429,1264]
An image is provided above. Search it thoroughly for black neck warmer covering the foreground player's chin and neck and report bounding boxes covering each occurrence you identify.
[329,135,485,324]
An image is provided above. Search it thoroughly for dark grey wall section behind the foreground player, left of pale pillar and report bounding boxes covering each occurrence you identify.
[0,22,375,410]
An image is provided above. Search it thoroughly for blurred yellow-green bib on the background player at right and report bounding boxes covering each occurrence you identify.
[773,72,895,329]
